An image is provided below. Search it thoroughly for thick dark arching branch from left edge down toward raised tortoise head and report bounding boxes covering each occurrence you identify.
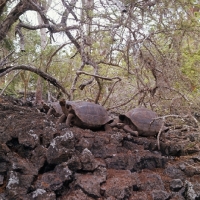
[0,65,70,99]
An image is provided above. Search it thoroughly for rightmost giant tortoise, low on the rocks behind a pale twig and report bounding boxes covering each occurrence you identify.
[112,107,167,136]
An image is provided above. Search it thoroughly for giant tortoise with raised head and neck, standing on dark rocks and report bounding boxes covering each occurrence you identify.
[60,99,112,131]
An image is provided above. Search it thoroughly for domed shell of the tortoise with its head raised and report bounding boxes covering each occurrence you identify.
[66,101,111,127]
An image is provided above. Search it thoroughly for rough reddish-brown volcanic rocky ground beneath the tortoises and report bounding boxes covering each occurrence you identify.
[0,97,200,200]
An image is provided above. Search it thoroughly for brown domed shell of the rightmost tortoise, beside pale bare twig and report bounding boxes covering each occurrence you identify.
[120,108,162,135]
